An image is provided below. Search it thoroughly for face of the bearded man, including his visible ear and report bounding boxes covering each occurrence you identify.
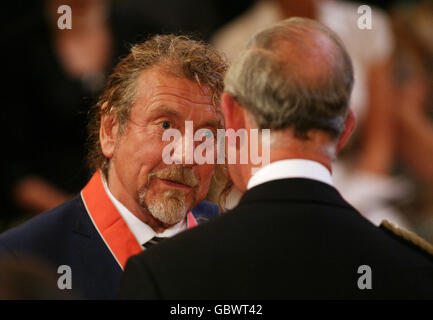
[101,66,218,226]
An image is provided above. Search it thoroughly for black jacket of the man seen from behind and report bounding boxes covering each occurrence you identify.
[122,178,433,299]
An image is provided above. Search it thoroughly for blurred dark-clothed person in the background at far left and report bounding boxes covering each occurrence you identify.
[2,0,119,231]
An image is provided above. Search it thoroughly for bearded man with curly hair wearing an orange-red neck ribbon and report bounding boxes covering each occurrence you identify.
[0,35,227,299]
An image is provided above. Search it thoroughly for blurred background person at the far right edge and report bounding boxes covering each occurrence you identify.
[391,1,433,242]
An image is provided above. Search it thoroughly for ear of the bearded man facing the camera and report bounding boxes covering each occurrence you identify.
[99,102,119,159]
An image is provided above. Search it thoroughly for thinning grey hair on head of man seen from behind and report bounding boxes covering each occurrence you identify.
[224,18,354,139]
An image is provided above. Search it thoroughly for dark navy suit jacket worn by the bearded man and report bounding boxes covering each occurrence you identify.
[0,196,218,299]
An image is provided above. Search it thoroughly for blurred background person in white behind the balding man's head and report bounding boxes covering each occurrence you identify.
[213,0,411,228]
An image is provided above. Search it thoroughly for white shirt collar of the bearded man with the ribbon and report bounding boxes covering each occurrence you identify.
[101,175,187,245]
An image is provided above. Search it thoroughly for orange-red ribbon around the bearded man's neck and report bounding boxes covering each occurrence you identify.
[81,170,197,270]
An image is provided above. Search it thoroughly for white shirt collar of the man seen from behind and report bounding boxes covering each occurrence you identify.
[247,159,333,189]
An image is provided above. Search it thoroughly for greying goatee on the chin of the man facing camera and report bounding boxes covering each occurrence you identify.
[139,188,188,225]
